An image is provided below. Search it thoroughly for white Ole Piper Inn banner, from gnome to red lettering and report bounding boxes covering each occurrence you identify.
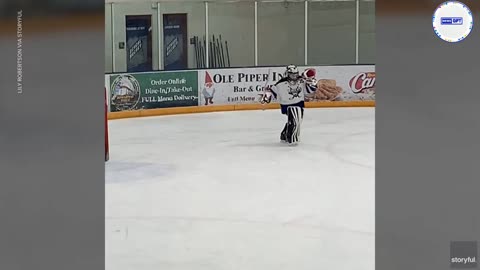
[198,65,375,106]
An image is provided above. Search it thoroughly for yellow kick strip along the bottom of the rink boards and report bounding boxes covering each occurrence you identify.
[108,100,375,120]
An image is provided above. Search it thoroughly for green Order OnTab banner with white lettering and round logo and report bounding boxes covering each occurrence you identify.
[109,71,198,112]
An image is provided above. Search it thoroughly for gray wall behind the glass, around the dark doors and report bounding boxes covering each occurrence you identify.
[105,0,375,72]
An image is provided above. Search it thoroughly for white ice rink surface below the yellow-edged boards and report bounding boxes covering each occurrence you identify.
[105,108,375,270]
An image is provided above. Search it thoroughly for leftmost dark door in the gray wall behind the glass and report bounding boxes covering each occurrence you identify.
[125,15,153,72]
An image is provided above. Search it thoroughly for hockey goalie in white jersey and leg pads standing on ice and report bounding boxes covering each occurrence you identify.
[260,65,317,145]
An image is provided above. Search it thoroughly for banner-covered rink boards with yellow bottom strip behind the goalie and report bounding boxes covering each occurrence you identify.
[105,65,376,118]
